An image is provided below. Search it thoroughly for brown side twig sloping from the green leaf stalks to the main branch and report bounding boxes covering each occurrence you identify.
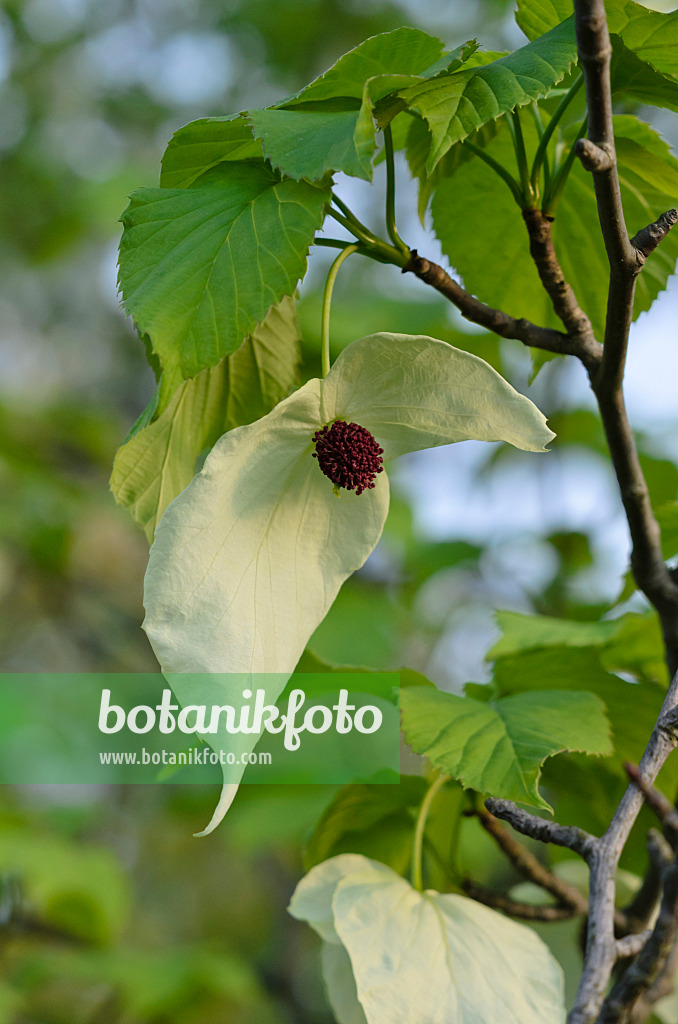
[402,250,602,372]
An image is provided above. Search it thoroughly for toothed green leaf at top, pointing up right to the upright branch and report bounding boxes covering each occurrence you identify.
[385,24,577,174]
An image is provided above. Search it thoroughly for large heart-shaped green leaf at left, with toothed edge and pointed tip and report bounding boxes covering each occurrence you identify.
[120,161,329,414]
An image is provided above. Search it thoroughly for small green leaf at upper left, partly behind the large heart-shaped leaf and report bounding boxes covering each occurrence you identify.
[160,114,262,188]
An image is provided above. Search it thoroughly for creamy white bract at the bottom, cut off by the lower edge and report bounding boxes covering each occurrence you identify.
[290,853,565,1024]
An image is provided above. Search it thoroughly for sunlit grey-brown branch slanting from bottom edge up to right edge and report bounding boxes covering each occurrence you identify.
[567,675,678,1024]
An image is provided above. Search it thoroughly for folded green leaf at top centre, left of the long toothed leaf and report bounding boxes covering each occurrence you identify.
[248,28,475,181]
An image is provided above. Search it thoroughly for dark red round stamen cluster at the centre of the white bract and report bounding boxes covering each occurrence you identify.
[313,420,384,495]
